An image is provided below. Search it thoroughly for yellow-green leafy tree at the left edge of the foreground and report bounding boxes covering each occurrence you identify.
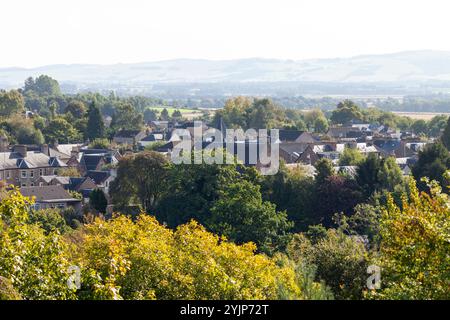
[0,188,75,299]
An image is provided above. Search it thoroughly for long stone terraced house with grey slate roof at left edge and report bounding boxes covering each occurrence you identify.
[0,145,67,187]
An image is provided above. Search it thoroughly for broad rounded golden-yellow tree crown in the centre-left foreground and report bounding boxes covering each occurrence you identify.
[72,214,300,299]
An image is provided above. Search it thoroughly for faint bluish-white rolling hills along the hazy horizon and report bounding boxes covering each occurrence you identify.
[0,51,450,92]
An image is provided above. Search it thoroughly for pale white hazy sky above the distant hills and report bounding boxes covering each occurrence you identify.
[0,0,450,67]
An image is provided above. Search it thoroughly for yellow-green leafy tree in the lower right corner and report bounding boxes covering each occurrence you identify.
[372,179,450,299]
